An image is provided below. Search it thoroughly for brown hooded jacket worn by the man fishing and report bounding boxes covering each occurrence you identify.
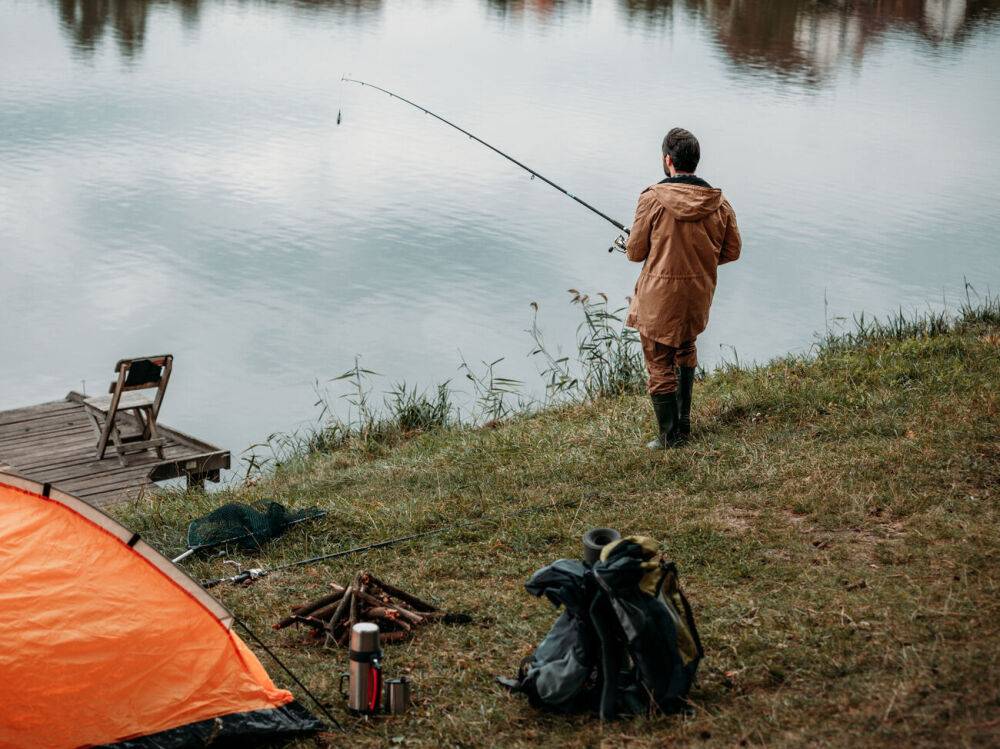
[626,178,740,347]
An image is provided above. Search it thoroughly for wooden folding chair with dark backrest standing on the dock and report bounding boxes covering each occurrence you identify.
[83,354,174,466]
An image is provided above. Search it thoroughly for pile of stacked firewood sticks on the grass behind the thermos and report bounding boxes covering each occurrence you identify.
[273,571,445,647]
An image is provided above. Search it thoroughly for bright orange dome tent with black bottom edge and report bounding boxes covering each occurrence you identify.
[0,473,322,749]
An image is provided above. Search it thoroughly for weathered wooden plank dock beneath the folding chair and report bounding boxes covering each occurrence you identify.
[0,392,230,507]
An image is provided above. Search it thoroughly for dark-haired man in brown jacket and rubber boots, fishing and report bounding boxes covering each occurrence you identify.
[626,127,741,449]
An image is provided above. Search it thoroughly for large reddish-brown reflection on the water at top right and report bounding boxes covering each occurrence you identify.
[620,0,1000,83]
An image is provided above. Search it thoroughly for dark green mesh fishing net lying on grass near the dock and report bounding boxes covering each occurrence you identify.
[188,502,326,549]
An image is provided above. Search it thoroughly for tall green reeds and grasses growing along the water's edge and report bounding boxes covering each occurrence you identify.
[254,282,1000,464]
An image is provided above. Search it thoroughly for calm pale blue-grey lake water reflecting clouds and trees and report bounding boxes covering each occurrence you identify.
[0,0,1000,462]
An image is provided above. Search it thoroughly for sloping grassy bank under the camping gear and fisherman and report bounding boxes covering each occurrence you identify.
[118,303,1000,747]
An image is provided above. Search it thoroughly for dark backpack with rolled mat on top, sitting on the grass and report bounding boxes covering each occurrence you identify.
[499,537,704,720]
